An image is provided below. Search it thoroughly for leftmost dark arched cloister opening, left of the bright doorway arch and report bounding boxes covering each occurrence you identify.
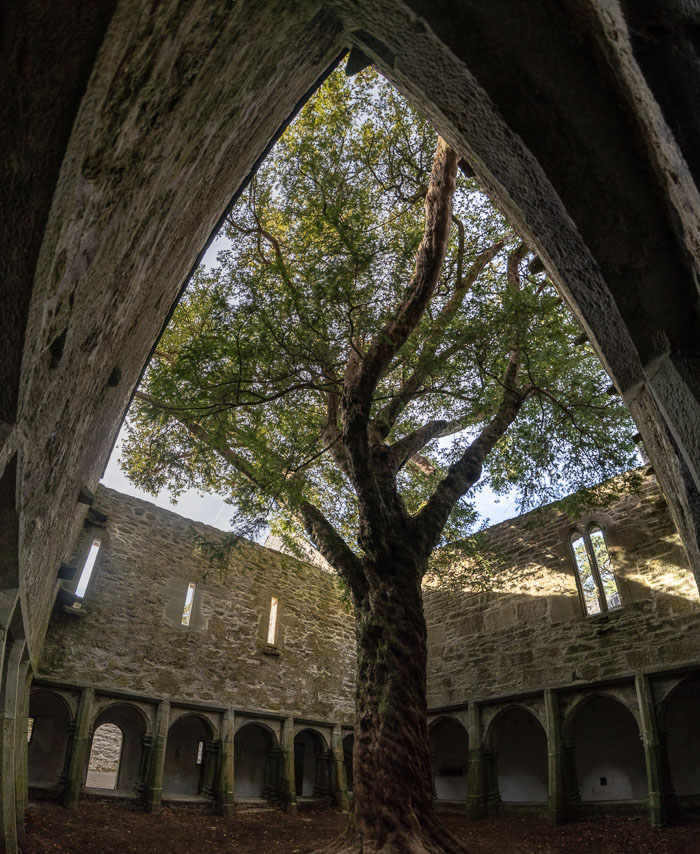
[27,688,73,787]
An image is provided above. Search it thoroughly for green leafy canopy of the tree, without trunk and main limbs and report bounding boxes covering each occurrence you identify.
[124,67,635,550]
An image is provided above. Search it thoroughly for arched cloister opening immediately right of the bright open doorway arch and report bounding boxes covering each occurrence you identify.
[163,712,214,797]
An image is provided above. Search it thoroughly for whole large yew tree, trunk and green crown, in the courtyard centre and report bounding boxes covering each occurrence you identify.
[124,72,634,854]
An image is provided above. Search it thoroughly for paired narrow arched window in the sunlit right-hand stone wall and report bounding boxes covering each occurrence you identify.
[570,525,622,615]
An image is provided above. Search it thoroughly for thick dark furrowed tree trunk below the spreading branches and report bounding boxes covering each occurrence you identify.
[326,566,465,854]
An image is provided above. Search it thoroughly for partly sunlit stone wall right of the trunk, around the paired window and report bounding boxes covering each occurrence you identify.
[424,478,700,708]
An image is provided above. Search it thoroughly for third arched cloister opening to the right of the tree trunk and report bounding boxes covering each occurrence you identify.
[565,693,648,801]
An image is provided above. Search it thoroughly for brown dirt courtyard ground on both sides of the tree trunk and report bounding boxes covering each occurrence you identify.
[24,801,700,854]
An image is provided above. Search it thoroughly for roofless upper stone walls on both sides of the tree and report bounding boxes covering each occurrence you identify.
[38,478,700,723]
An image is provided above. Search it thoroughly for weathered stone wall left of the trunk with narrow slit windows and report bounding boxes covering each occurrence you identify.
[39,487,355,721]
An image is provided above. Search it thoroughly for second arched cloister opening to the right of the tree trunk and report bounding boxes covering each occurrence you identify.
[486,705,549,803]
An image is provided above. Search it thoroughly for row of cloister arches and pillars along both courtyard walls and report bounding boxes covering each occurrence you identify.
[28,673,700,820]
